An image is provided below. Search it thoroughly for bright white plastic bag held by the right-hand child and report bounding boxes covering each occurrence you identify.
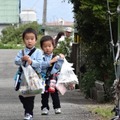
[56,58,78,95]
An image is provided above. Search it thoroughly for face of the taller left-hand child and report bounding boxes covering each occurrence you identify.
[24,33,36,49]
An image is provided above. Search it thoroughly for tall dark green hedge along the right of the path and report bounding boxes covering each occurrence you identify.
[69,0,118,98]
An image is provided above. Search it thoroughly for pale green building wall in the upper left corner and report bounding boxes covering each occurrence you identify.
[0,0,21,24]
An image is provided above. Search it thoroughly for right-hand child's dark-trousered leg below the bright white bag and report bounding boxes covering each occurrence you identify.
[51,90,61,109]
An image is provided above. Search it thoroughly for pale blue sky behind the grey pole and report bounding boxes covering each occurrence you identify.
[21,0,74,23]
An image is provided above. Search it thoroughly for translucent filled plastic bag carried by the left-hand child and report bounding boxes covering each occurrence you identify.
[19,65,45,97]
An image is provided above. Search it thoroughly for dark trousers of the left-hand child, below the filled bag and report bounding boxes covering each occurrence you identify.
[19,95,35,115]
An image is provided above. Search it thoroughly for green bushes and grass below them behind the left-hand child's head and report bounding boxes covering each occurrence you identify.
[0,22,41,49]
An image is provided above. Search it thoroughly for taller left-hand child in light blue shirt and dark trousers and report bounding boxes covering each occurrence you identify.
[15,28,42,120]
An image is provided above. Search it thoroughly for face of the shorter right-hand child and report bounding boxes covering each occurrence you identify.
[42,41,54,55]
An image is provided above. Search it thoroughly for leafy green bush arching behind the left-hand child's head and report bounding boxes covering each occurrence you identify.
[0,22,41,45]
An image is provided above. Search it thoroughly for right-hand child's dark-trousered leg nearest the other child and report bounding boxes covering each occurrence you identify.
[41,92,49,110]
